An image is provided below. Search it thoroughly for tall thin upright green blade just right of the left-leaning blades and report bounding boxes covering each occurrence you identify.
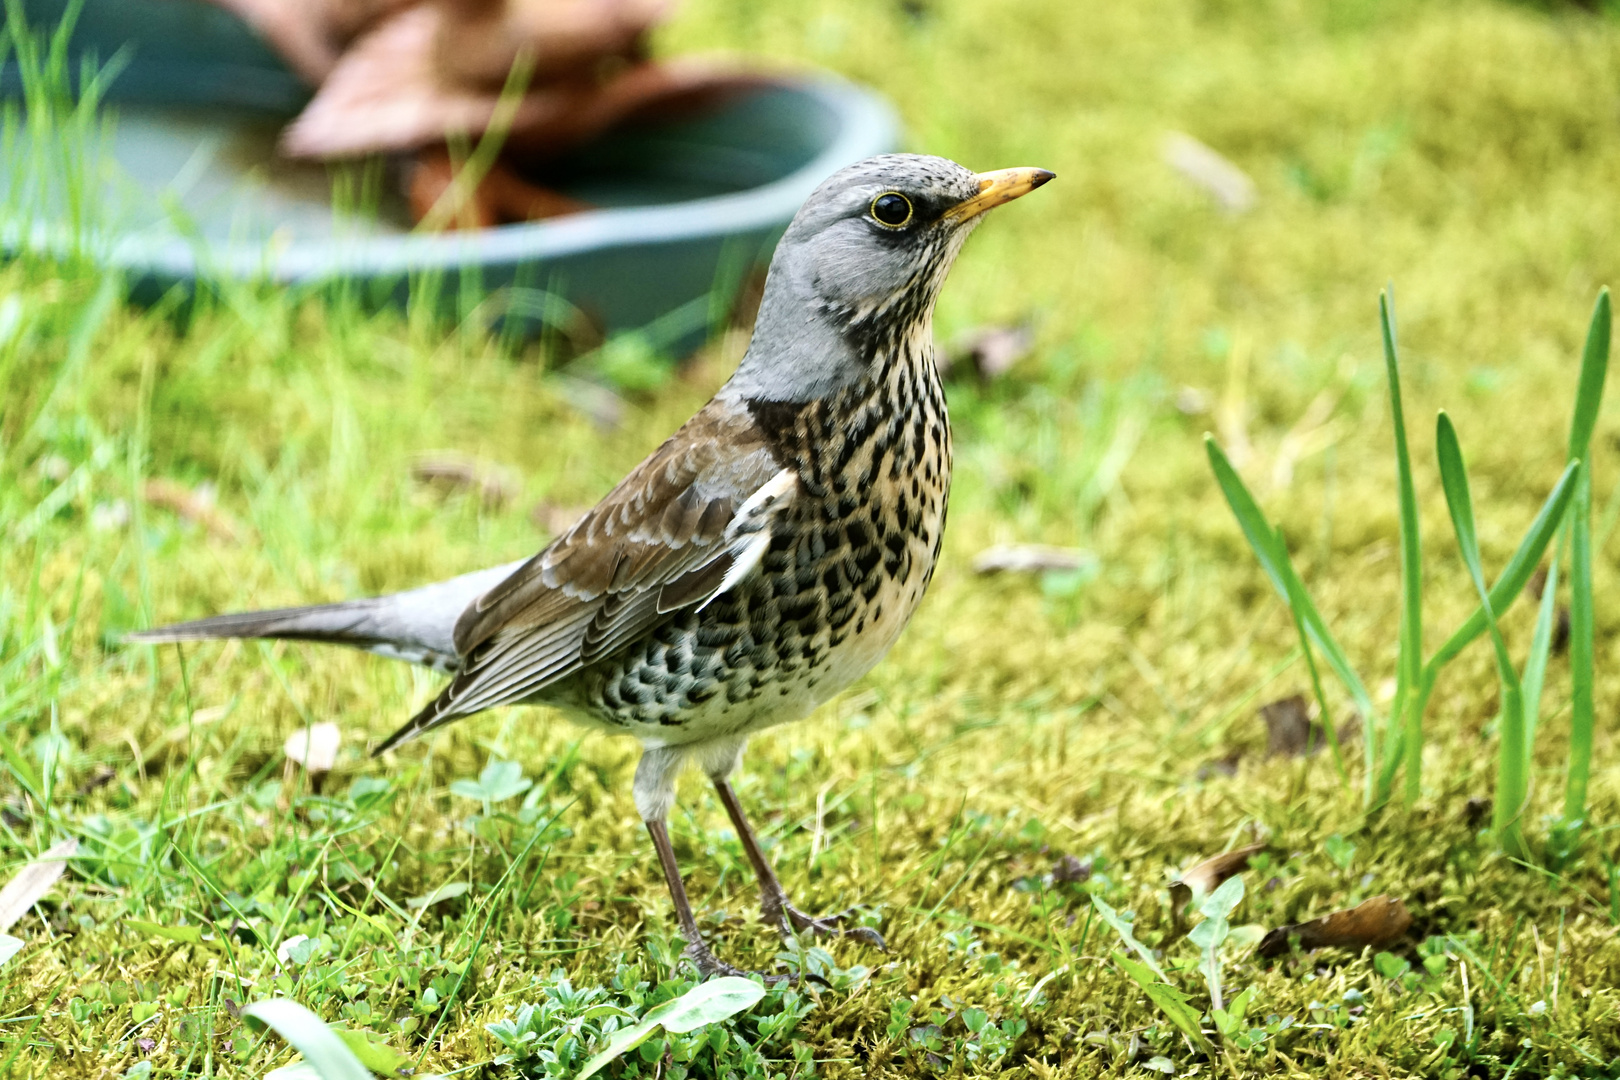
[1367,290,1422,805]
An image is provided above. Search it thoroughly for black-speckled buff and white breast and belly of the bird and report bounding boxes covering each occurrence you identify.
[567,355,951,743]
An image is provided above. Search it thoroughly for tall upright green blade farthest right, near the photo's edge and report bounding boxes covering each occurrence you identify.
[1560,288,1612,848]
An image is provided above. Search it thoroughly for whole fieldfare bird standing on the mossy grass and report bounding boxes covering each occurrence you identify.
[133,154,1053,975]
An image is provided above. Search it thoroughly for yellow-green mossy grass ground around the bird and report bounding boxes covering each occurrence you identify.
[0,0,1620,1077]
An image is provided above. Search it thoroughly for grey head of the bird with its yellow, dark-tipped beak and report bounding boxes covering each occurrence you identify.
[726,154,1051,402]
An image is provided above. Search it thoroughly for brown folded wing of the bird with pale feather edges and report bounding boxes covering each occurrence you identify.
[376,402,791,753]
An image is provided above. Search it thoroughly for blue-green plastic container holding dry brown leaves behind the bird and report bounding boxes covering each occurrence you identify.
[0,0,899,345]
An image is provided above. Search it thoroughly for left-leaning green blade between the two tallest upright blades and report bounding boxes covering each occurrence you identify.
[1435,411,1529,858]
